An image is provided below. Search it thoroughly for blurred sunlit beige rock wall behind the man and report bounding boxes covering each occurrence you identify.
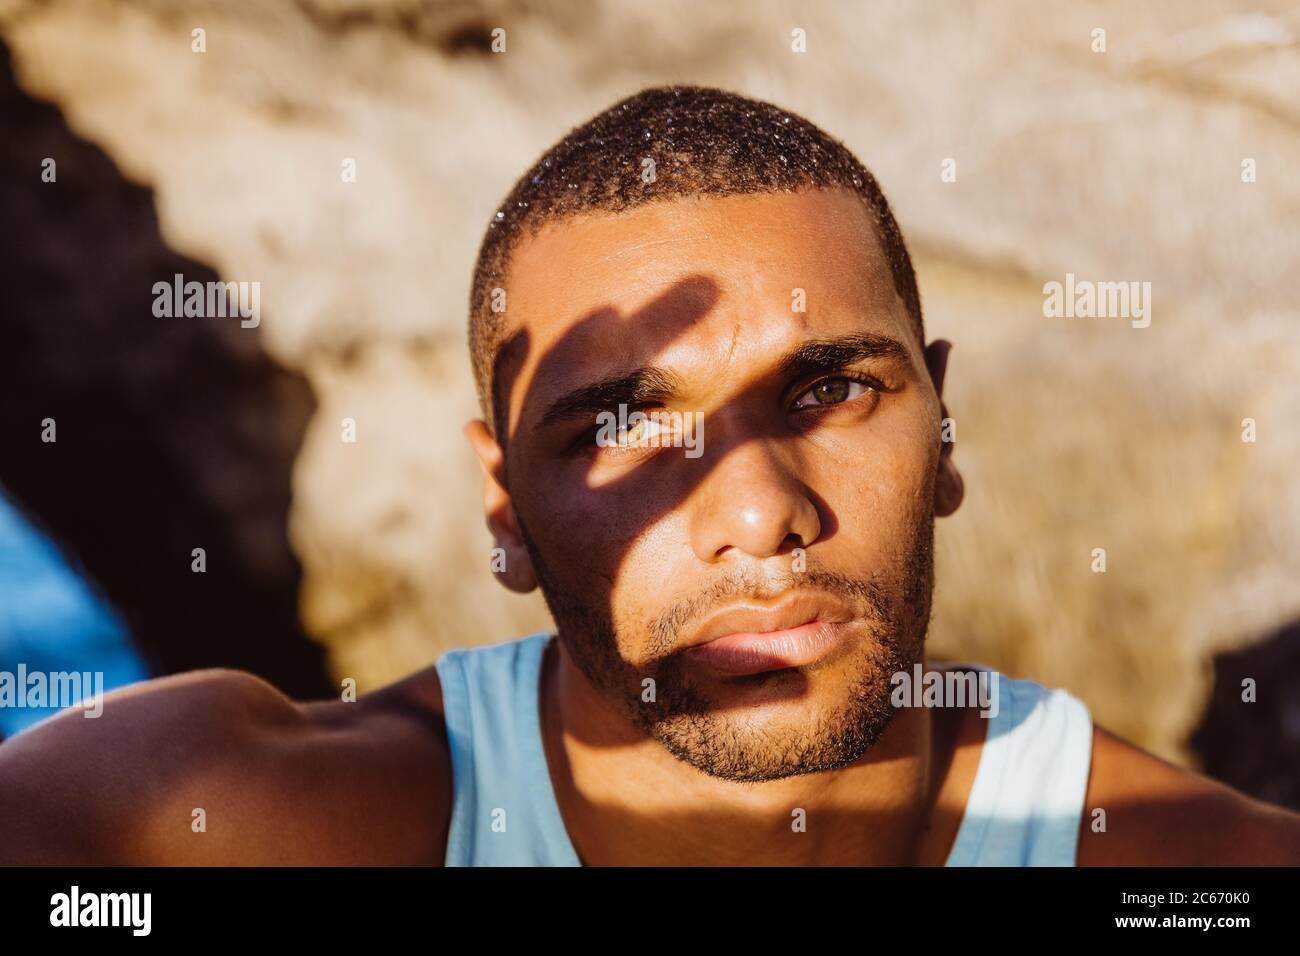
[0,0,1300,780]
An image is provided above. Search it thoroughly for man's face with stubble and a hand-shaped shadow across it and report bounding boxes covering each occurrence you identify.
[469,190,961,780]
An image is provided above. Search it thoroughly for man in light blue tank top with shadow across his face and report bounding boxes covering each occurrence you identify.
[0,87,1300,865]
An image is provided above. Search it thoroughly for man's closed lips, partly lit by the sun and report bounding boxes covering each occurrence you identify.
[686,597,853,676]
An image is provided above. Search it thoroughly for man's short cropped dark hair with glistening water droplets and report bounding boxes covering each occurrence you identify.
[469,86,926,441]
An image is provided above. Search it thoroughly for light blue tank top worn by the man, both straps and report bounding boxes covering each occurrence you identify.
[437,632,1092,866]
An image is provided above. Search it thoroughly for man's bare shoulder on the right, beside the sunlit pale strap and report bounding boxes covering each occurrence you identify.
[1078,727,1300,866]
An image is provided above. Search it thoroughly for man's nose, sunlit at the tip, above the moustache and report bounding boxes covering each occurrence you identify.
[690,440,822,563]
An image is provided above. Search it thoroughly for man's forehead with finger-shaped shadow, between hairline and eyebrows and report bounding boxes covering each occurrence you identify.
[502,189,920,425]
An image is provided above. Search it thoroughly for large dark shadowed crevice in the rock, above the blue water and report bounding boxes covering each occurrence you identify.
[0,37,333,697]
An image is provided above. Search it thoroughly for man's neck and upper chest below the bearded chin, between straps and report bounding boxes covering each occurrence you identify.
[541,640,969,866]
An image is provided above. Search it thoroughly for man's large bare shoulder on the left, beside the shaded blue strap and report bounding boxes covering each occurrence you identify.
[0,667,451,865]
